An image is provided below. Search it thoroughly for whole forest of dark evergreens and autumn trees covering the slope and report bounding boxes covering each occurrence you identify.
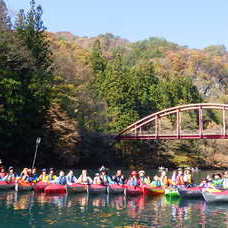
[0,0,228,168]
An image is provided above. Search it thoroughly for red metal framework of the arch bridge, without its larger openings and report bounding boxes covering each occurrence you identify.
[117,103,228,140]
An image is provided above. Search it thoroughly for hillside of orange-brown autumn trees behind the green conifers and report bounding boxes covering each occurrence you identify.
[48,32,228,167]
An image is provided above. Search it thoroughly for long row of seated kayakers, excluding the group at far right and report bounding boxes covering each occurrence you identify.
[0,166,193,187]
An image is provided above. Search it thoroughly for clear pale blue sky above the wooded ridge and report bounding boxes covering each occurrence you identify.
[5,0,228,48]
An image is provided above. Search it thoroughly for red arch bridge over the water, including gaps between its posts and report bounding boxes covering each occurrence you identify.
[117,103,228,140]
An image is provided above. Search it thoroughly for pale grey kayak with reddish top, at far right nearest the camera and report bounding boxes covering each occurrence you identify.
[202,190,228,203]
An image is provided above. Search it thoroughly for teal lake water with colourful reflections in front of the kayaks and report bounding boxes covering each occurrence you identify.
[0,170,228,228]
